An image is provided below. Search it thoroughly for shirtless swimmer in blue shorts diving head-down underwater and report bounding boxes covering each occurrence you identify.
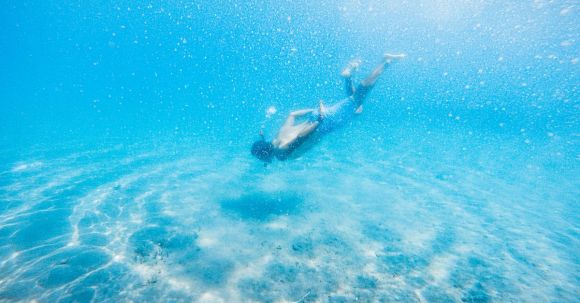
[252,54,406,165]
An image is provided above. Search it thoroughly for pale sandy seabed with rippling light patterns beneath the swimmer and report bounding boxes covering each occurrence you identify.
[0,135,580,302]
